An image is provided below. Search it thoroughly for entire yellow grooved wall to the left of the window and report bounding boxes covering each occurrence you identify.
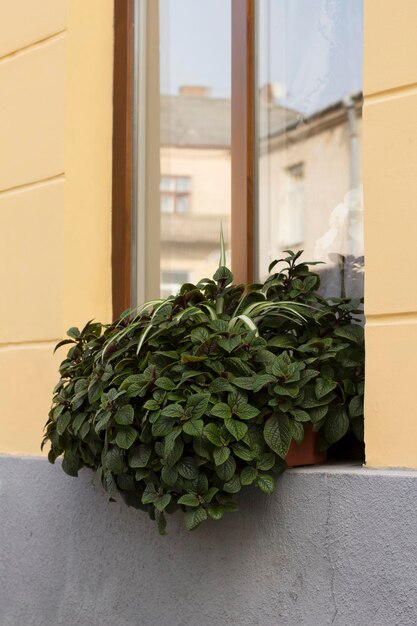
[0,0,113,454]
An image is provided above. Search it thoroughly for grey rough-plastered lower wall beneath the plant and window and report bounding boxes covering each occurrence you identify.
[0,456,417,626]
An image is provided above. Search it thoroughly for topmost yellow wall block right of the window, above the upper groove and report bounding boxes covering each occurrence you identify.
[364,0,417,95]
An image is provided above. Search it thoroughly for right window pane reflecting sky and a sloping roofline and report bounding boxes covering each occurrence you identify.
[257,0,364,296]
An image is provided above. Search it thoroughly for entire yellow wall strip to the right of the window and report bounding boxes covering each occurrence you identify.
[363,0,417,467]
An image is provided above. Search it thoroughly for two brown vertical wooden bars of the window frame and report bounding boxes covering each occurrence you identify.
[112,0,256,318]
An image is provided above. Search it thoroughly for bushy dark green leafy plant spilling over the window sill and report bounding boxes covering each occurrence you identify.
[42,251,364,533]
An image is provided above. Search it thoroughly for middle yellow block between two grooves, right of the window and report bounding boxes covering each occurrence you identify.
[364,90,417,314]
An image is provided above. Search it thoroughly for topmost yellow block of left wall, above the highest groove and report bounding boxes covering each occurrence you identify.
[0,0,66,57]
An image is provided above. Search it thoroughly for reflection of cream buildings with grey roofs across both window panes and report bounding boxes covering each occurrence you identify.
[160,85,363,296]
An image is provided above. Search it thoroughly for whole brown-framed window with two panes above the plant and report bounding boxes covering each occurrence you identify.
[113,0,364,311]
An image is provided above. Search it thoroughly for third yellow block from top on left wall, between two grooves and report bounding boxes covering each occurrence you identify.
[0,178,64,344]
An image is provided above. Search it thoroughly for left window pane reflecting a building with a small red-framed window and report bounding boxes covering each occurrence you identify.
[137,0,231,299]
